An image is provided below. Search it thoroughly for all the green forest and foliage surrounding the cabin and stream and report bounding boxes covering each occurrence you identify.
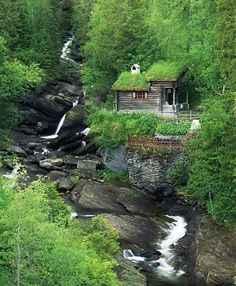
[0,0,236,286]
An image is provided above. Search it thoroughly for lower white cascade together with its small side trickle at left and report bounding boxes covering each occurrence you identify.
[123,215,187,279]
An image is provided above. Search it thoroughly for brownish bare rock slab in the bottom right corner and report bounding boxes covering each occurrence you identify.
[191,216,236,286]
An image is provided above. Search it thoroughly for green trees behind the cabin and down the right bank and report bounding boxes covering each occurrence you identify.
[73,0,236,222]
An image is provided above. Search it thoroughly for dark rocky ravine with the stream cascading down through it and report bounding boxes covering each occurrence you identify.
[1,39,236,286]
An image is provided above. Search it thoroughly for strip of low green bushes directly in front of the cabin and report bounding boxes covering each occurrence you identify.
[88,110,190,147]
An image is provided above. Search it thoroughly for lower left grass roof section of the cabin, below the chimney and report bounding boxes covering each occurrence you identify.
[112,72,149,91]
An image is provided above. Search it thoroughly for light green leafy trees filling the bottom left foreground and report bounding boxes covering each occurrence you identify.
[0,178,120,286]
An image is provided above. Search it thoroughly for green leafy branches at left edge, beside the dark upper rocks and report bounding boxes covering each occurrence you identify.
[0,37,43,146]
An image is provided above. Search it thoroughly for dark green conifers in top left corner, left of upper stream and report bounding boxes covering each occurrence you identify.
[0,0,61,70]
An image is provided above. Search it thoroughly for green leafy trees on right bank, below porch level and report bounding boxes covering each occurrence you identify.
[185,94,236,226]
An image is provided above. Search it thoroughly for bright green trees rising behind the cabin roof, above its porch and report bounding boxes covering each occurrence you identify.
[73,0,236,97]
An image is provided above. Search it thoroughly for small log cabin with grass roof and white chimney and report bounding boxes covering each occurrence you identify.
[113,62,189,116]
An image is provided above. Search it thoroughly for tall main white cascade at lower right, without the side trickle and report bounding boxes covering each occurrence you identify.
[157,216,187,278]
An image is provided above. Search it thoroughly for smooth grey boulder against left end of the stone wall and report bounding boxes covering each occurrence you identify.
[100,146,128,175]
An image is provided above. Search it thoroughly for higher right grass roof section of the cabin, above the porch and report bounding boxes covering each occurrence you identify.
[146,61,184,81]
